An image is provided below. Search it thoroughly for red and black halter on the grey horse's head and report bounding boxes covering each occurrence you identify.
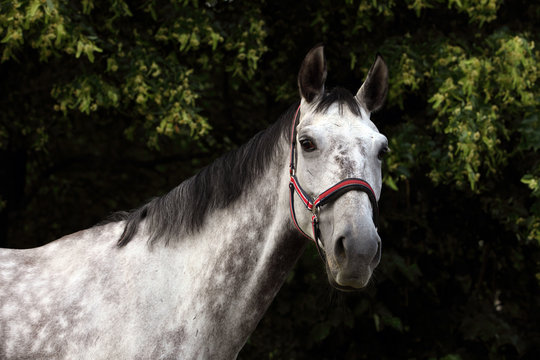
[289,105,379,262]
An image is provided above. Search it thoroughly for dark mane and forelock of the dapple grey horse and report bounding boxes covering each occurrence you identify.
[112,87,361,247]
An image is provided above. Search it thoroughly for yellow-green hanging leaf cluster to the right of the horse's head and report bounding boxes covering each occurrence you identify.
[391,31,538,192]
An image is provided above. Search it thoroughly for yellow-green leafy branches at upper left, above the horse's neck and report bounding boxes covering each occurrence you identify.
[0,0,266,149]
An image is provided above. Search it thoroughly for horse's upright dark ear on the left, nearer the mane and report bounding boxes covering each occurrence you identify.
[298,45,326,103]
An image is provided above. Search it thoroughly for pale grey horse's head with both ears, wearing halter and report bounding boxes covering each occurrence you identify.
[291,46,388,290]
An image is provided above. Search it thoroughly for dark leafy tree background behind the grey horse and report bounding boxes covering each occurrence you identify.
[0,0,540,360]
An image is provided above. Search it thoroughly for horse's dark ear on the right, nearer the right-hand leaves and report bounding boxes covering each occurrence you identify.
[356,54,388,112]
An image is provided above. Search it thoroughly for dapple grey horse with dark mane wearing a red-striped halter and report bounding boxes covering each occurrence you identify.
[0,46,388,360]
